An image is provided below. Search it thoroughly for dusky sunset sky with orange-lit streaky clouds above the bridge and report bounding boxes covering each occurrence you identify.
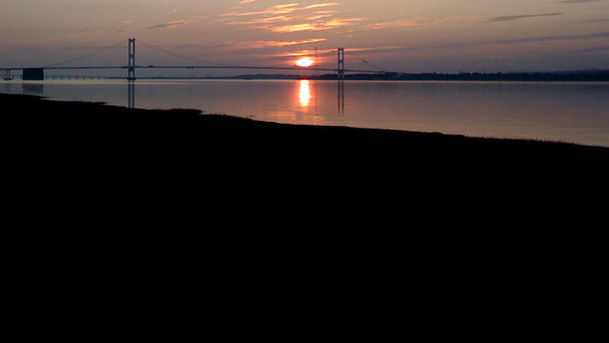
[0,0,609,72]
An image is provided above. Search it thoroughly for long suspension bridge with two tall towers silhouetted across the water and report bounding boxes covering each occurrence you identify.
[0,38,384,82]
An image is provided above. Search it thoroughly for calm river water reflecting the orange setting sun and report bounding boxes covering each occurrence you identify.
[0,80,609,147]
